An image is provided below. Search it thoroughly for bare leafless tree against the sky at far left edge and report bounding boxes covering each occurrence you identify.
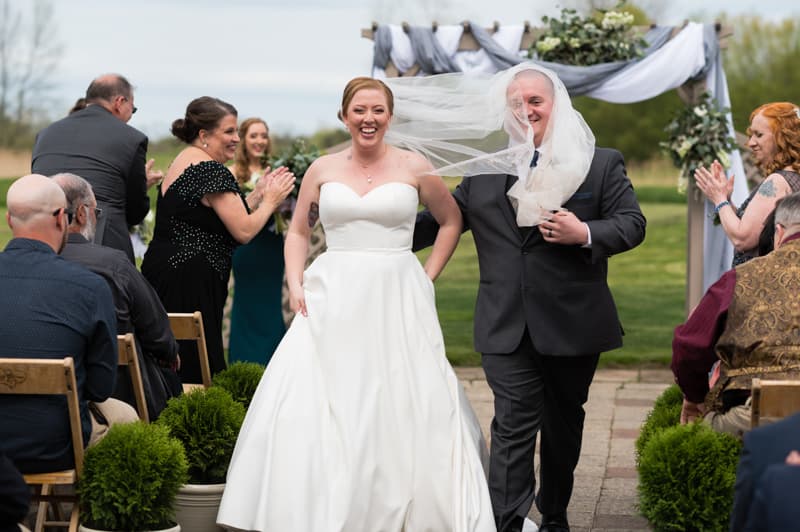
[0,0,61,148]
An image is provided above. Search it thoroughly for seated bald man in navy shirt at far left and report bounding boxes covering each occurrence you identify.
[0,174,137,473]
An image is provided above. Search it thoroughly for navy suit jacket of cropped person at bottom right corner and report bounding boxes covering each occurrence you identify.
[731,414,800,532]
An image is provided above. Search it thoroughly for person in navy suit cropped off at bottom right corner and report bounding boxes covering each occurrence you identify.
[731,414,800,532]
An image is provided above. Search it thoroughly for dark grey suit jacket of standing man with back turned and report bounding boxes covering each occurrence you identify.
[31,105,150,262]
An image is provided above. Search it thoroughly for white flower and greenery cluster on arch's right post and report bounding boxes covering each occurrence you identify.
[660,93,736,192]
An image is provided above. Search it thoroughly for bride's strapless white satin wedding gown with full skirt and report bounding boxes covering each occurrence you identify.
[217,182,495,532]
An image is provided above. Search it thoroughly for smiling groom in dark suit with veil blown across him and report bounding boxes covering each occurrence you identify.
[414,67,645,532]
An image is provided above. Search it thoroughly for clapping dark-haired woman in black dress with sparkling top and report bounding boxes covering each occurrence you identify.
[142,96,294,383]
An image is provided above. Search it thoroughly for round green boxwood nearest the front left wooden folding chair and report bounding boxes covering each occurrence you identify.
[78,423,188,530]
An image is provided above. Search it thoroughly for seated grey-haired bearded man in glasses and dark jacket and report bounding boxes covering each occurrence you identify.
[53,173,181,420]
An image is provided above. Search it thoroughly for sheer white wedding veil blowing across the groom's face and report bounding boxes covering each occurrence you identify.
[383,63,594,226]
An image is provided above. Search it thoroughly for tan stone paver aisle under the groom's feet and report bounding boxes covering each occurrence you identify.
[456,368,672,532]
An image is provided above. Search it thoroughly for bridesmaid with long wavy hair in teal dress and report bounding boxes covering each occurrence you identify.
[228,118,286,364]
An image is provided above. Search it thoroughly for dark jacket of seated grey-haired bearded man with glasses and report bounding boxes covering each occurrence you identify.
[61,233,180,420]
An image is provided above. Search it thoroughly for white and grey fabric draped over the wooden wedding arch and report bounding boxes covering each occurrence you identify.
[361,22,747,311]
